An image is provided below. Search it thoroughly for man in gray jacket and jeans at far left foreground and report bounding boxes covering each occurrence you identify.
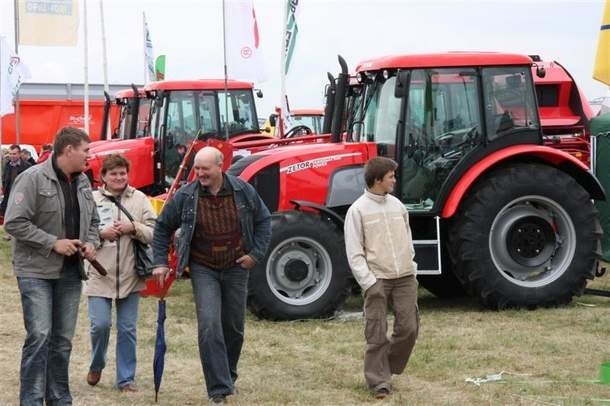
[4,127,99,405]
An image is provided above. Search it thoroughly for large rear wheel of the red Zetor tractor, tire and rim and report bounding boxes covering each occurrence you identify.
[449,163,601,309]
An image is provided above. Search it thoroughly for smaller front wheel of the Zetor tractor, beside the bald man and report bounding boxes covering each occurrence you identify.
[248,211,351,320]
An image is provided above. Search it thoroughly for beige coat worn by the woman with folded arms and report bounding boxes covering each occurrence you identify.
[85,186,156,299]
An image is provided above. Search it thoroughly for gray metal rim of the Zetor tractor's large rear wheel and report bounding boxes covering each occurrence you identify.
[489,195,576,288]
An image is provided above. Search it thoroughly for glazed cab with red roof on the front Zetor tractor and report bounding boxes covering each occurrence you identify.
[347,54,542,212]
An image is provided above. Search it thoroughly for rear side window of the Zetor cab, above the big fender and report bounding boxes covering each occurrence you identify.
[483,66,539,140]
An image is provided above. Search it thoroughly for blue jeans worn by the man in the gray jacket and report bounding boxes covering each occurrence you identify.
[17,272,82,406]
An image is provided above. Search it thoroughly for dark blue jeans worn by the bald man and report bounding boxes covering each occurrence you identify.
[190,262,249,397]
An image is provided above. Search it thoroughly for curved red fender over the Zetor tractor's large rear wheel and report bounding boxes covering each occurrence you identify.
[441,145,606,218]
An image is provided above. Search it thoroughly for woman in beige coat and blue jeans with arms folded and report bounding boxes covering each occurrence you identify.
[85,154,156,392]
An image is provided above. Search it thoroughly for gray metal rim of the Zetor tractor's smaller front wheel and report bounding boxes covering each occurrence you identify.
[267,237,332,306]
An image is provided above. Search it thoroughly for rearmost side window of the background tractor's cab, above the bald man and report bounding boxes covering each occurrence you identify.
[218,90,258,137]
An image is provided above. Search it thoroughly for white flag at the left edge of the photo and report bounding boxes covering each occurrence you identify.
[0,37,31,116]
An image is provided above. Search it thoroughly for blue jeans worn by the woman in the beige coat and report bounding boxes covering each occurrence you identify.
[89,292,140,388]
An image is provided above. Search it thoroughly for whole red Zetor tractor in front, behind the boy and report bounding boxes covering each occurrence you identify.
[230,53,605,320]
